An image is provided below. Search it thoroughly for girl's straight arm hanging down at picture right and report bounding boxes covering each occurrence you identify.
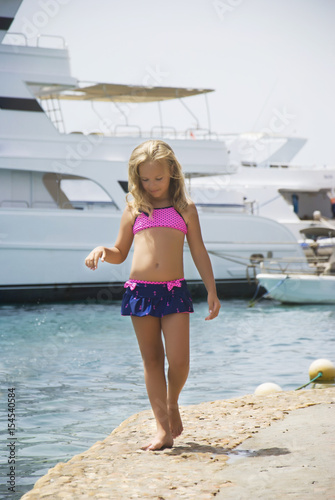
[187,204,221,319]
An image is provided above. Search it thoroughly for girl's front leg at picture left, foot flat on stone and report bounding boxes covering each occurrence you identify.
[132,316,173,450]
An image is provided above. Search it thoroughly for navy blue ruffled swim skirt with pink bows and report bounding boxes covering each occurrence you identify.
[121,279,193,318]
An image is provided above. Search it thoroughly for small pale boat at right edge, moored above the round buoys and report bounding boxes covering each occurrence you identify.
[257,252,335,304]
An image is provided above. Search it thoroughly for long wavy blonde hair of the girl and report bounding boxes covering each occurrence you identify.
[127,140,190,215]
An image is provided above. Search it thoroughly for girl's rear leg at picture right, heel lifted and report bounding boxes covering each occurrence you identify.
[162,313,190,438]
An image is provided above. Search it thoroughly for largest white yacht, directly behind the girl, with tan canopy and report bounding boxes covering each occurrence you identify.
[0,0,303,303]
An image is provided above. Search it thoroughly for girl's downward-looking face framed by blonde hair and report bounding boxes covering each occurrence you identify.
[138,160,170,200]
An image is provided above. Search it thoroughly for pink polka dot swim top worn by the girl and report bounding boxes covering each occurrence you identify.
[133,207,187,234]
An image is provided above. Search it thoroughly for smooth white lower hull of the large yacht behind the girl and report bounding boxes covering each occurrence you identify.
[0,209,303,303]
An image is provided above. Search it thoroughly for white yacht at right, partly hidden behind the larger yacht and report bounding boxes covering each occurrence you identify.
[190,133,335,241]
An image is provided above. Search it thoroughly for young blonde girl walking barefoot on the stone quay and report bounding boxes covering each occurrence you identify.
[85,140,220,450]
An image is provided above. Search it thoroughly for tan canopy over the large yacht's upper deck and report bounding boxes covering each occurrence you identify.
[27,82,214,103]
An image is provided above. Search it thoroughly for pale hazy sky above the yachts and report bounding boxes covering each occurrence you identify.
[12,0,335,166]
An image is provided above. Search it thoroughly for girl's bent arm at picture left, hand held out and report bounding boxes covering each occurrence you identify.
[85,207,134,270]
